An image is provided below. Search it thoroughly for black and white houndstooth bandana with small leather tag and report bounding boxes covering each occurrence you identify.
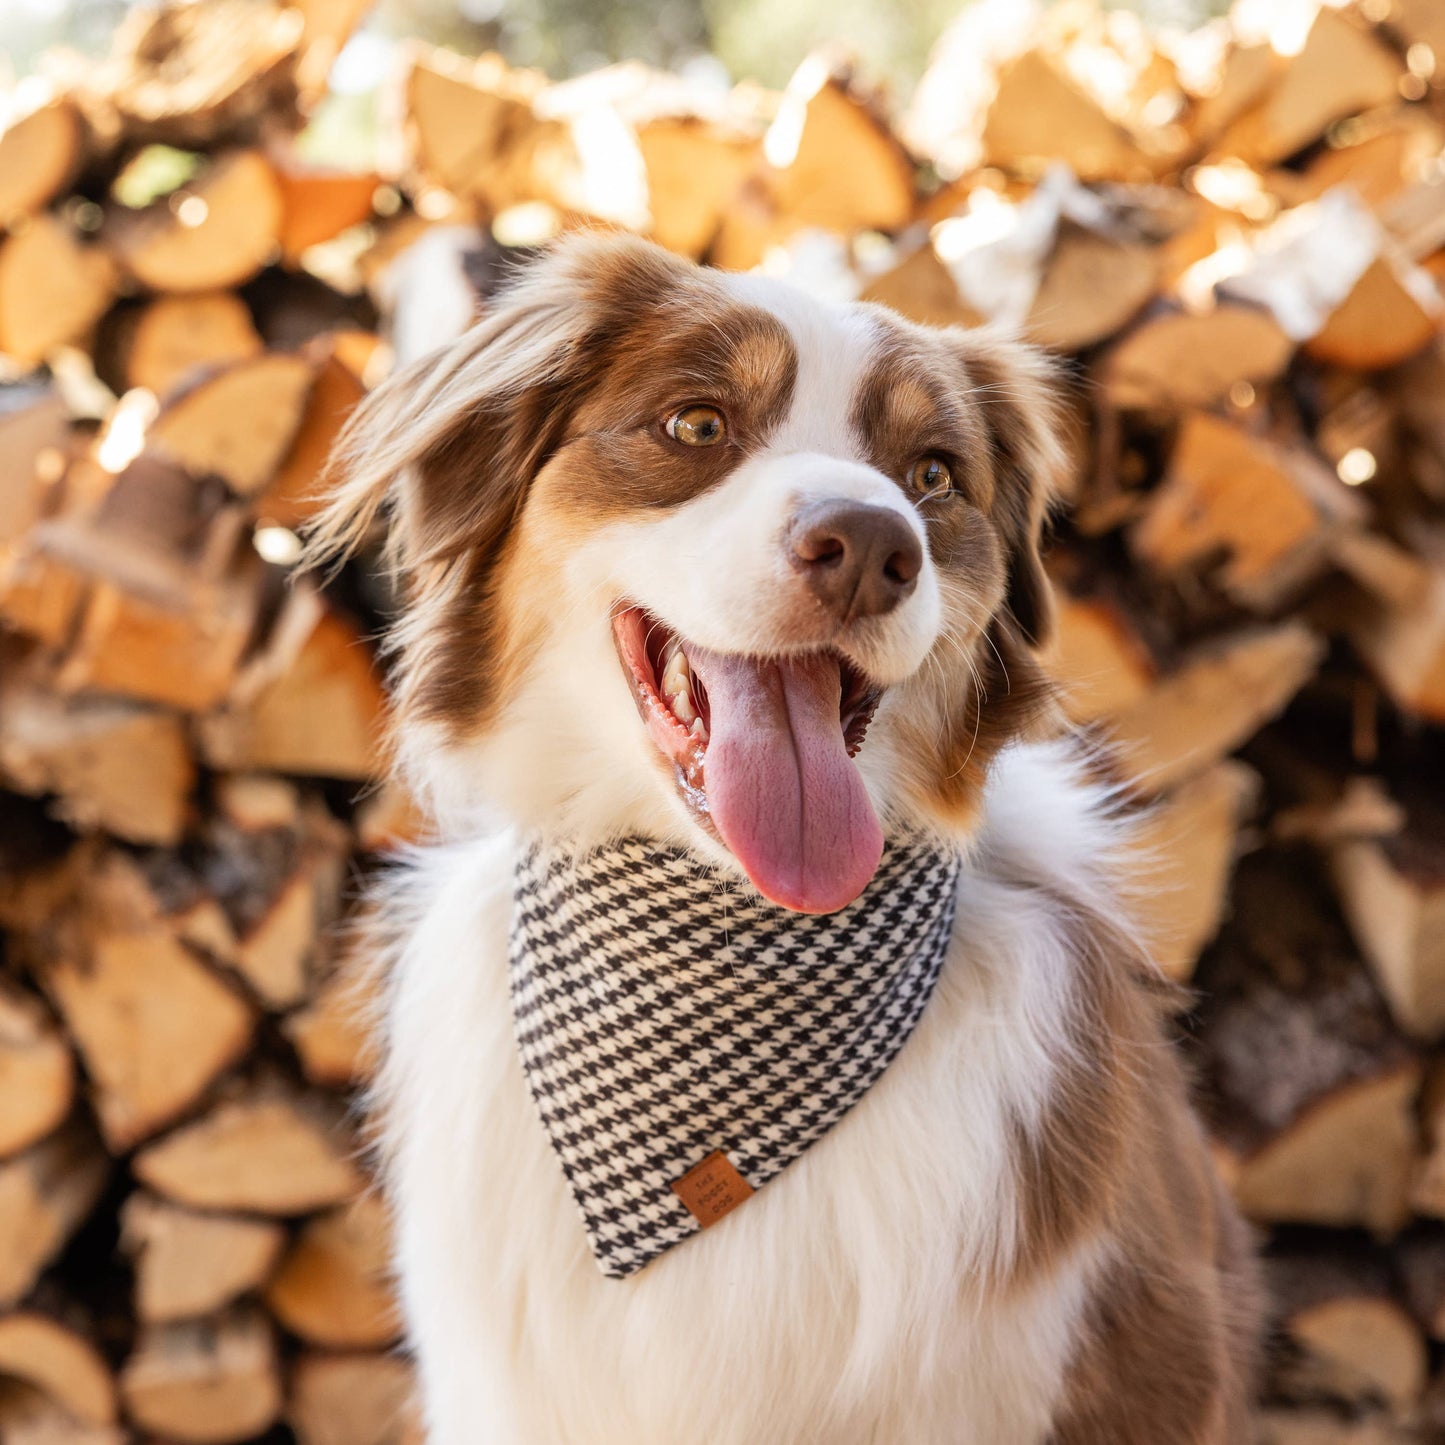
[510,837,959,1279]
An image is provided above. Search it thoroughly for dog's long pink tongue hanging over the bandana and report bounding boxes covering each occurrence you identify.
[688,647,883,913]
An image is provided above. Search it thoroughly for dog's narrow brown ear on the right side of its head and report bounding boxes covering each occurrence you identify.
[955,328,1066,647]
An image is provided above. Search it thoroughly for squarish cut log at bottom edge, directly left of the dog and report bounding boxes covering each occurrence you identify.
[286,1353,422,1445]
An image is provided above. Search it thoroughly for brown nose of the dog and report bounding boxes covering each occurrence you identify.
[788,500,923,623]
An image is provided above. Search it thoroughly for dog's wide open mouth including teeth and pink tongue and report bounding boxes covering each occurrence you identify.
[613,607,883,913]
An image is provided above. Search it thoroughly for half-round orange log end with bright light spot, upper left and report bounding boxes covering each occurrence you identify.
[103,150,282,292]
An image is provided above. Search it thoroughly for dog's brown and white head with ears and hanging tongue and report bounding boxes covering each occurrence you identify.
[314,234,1061,912]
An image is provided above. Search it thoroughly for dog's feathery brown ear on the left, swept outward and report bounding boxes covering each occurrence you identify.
[306,233,676,579]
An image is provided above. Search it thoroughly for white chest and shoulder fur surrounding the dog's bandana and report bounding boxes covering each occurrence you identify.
[381,749,1113,1445]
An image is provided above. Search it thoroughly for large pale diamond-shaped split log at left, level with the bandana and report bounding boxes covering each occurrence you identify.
[42,855,254,1152]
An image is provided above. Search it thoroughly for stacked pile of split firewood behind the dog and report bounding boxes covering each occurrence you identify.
[0,0,1445,1445]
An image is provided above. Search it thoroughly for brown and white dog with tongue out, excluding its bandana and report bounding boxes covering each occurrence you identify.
[314,234,1254,1445]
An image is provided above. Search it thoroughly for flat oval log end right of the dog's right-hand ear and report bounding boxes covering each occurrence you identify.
[1100,303,1293,410]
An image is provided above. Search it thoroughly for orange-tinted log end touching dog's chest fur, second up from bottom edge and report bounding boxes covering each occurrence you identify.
[266,1194,399,1350]
